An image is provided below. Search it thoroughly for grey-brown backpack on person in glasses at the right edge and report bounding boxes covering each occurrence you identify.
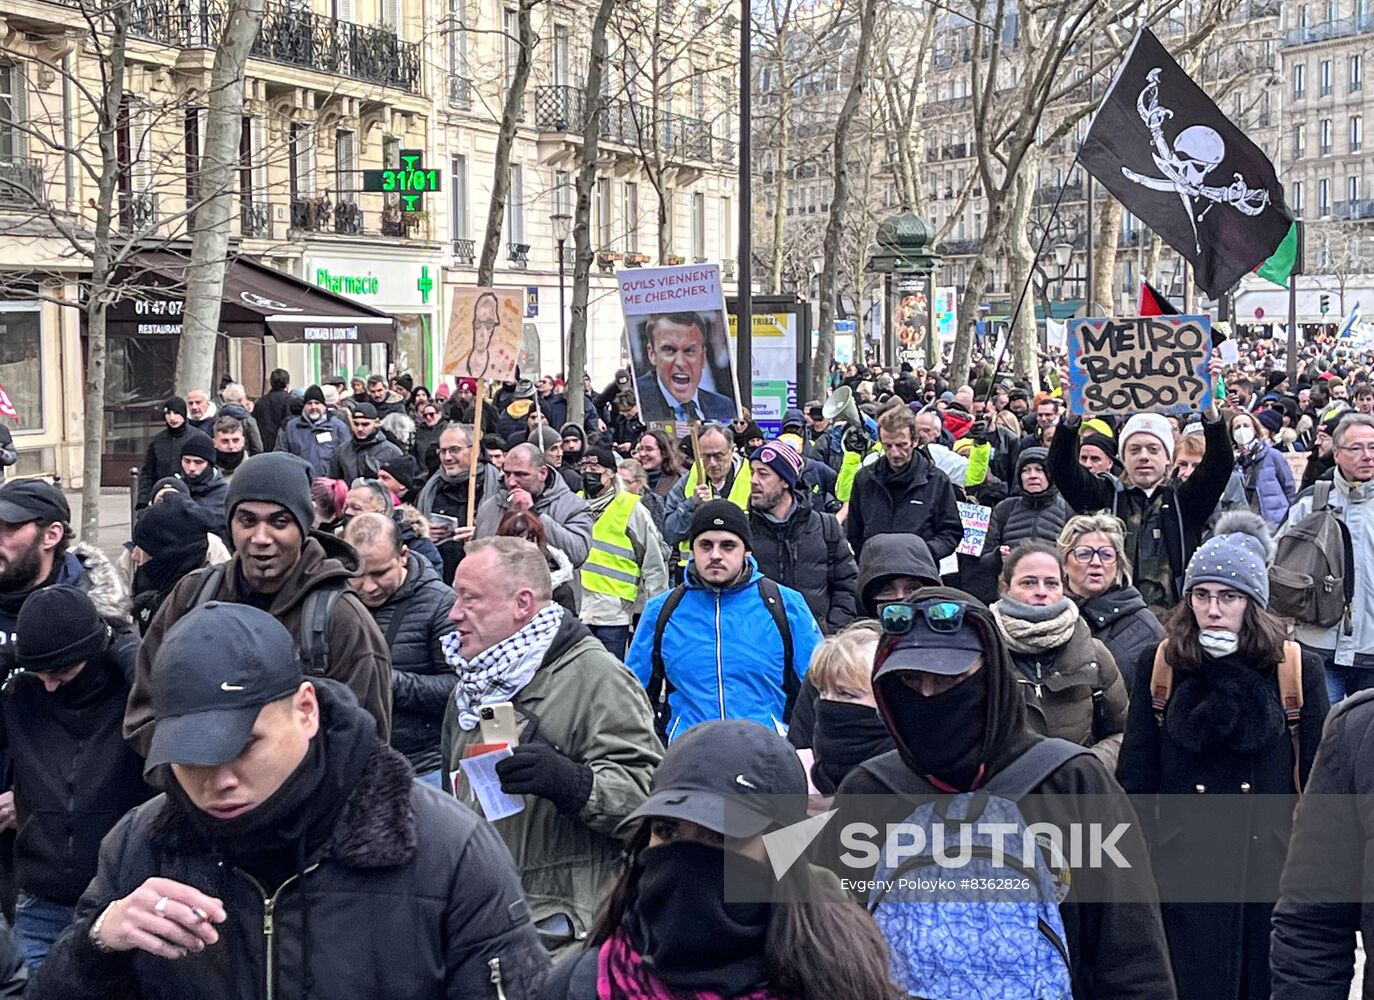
[1270,479,1355,635]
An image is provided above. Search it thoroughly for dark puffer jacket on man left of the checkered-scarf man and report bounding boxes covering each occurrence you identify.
[372,552,458,775]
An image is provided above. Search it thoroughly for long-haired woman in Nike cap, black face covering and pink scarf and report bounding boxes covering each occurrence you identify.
[543,721,904,1000]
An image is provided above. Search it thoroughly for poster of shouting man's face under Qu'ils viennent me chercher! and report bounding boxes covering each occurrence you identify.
[617,264,739,429]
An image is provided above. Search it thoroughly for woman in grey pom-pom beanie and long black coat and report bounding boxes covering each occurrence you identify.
[1117,511,1329,1000]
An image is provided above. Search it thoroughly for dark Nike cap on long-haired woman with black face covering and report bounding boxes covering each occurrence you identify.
[617,720,807,838]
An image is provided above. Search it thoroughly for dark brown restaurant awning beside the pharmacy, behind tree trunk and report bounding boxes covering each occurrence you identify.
[106,250,396,343]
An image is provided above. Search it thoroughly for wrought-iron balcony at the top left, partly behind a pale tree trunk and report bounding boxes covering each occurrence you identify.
[129,0,420,93]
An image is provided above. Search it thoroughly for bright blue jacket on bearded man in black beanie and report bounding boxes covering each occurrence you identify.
[625,556,820,739]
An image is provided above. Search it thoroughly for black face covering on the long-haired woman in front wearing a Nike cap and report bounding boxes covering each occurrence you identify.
[625,841,775,996]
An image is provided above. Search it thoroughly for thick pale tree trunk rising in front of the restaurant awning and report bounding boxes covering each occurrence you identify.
[174,0,262,396]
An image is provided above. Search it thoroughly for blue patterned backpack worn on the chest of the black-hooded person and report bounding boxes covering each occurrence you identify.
[863,739,1091,1000]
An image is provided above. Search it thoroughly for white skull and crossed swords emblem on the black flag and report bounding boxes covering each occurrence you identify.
[1121,69,1270,253]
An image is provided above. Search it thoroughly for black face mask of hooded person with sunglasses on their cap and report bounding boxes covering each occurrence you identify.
[879,668,988,791]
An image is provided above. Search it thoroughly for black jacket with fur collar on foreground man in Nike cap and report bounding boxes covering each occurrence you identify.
[27,681,548,1000]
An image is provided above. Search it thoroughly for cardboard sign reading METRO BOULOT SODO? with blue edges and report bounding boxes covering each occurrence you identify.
[1069,316,1212,416]
